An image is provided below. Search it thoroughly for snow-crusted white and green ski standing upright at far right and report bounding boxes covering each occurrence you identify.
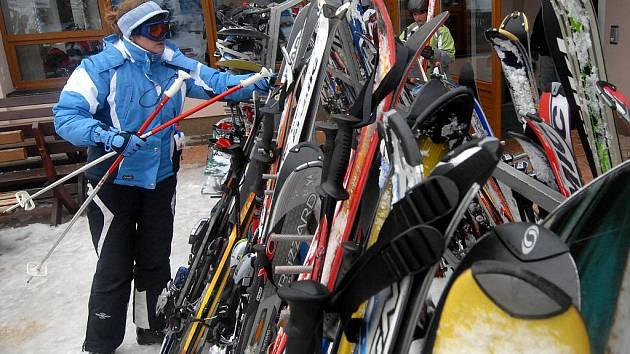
[542,0,622,175]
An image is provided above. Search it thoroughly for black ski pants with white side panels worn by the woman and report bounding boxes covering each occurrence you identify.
[84,176,177,353]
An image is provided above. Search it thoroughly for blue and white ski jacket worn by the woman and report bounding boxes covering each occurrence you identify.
[53,35,262,189]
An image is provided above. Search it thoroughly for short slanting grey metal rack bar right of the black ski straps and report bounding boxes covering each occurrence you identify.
[492,161,567,211]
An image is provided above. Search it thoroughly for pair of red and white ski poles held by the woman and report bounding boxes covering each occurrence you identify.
[25,68,271,283]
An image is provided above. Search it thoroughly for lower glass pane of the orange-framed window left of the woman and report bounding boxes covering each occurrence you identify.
[15,41,102,80]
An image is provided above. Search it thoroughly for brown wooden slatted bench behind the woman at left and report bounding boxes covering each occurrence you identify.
[0,93,87,225]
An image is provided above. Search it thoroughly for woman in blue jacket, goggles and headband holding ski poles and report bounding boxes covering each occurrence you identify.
[53,0,269,353]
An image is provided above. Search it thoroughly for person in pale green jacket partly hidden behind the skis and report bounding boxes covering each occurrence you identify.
[400,0,455,75]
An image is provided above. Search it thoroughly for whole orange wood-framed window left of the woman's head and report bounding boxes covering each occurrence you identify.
[0,0,108,89]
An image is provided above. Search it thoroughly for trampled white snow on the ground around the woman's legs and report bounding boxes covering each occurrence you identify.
[0,166,214,354]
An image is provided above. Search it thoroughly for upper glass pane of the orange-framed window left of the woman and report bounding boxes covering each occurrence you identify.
[0,0,101,34]
